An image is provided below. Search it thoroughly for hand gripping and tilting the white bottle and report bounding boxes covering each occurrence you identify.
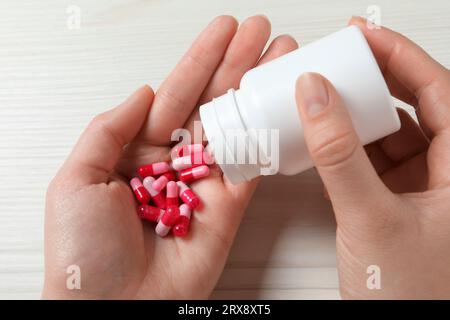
[297,18,450,299]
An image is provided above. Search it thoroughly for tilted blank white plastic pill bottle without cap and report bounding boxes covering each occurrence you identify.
[200,26,400,184]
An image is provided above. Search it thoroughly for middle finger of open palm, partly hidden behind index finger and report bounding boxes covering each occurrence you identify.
[185,16,270,135]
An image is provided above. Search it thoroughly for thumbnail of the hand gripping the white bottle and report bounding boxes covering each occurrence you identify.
[297,73,328,118]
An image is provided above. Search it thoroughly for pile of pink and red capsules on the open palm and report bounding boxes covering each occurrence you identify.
[130,144,213,237]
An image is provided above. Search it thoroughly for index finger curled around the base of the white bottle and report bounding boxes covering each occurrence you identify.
[350,17,450,133]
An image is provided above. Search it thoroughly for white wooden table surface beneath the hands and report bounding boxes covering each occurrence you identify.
[0,0,450,299]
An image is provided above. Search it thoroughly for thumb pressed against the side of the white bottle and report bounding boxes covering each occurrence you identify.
[296,73,389,220]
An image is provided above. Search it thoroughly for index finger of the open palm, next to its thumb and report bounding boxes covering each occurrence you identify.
[142,16,237,145]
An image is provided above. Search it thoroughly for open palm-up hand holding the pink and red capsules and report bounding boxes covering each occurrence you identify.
[43,16,297,299]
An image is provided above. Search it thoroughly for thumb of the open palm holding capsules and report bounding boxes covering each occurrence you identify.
[61,86,153,186]
